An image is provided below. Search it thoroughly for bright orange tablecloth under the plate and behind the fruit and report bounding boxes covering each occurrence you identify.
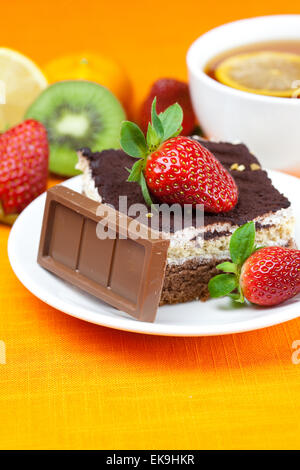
[0,0,300,449]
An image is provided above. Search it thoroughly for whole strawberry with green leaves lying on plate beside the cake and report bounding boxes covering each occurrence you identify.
[208,221,300,306]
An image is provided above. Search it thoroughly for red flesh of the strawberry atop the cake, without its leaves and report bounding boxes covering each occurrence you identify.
[144,136,238,212]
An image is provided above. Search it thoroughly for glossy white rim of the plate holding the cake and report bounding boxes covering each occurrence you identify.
[7,170,300,337]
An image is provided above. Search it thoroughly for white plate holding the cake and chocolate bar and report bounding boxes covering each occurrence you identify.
[8,171,300,336]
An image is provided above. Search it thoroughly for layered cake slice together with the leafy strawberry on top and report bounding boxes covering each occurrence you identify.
[78,101,294,305]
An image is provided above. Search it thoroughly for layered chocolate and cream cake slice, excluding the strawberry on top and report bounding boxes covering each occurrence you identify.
[77,137,294,305]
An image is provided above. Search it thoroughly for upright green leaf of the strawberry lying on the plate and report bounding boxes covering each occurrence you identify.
[230,222,255,265]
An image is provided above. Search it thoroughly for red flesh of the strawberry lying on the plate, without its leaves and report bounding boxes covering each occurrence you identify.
[240,246,300,306]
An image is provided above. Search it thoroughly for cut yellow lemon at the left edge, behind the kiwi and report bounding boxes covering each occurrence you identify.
[0,48,47,132]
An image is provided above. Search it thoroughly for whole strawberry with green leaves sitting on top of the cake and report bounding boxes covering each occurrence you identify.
[121,99,238,212]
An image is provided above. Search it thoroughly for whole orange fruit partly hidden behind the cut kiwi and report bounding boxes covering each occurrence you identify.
[44,52,132,109]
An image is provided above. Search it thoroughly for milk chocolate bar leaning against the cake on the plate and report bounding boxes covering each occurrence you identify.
[37,186,169,322]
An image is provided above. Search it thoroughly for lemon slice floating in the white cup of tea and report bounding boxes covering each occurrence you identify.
[215,52,300,97]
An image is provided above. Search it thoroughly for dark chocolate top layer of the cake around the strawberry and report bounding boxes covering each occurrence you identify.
[81,140,290,232]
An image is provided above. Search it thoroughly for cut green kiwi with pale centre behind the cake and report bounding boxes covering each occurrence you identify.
[25,80,126,176]
